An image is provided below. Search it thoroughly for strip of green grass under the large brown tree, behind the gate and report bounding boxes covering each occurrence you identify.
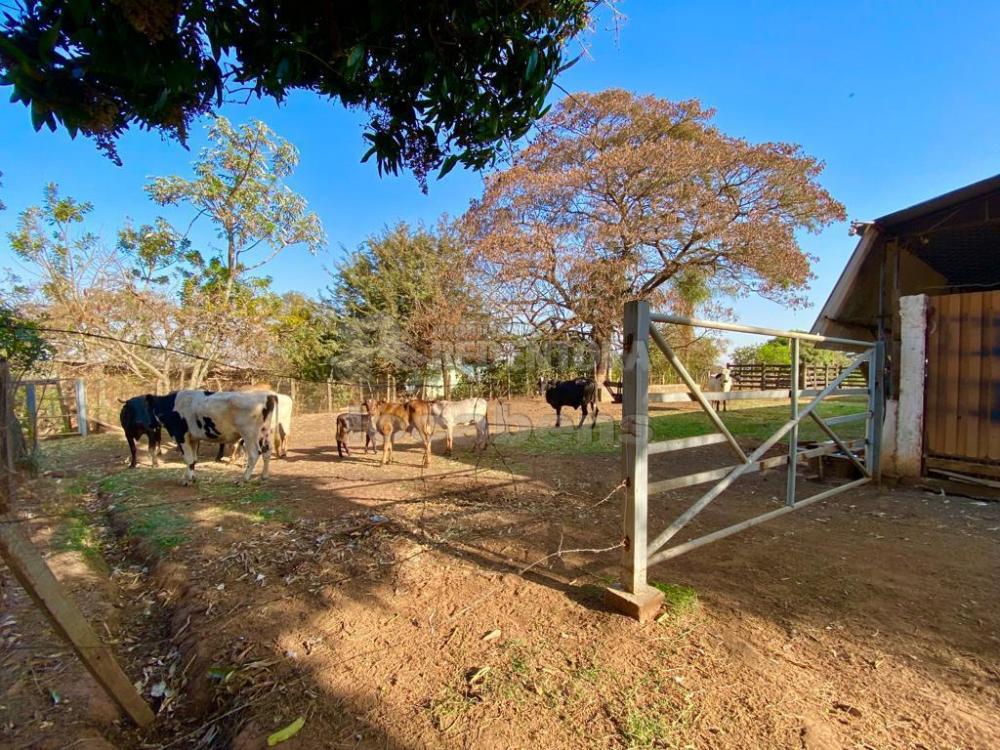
[495,398,865,455]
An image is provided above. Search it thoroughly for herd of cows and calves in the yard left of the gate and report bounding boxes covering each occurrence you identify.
[119,378,597,484]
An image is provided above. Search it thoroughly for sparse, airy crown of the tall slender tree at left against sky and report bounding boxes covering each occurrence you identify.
[146,117,326,301]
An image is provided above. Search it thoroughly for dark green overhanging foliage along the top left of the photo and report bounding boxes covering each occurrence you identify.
[0,0,599,185]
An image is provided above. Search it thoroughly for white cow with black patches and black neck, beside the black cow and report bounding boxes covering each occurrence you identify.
[146,391,278,484]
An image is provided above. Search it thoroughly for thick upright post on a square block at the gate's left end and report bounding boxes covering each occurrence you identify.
[605,301,663,622]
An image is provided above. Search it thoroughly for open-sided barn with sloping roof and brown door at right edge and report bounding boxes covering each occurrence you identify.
[812,175,1000,478]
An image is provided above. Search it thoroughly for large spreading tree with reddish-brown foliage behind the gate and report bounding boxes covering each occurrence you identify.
[467,90,844,396]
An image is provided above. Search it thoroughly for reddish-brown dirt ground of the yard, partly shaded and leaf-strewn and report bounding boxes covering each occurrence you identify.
[0,401,1000,750]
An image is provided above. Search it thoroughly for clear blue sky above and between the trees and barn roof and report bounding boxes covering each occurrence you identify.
[0,0,1000,350]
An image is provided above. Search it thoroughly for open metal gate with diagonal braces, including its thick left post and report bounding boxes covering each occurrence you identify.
[622,301,884,597]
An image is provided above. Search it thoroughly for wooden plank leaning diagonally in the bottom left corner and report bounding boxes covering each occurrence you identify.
[0,516,155,727]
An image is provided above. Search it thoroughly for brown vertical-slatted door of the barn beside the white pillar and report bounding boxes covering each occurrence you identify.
[924,291,1000,476]
